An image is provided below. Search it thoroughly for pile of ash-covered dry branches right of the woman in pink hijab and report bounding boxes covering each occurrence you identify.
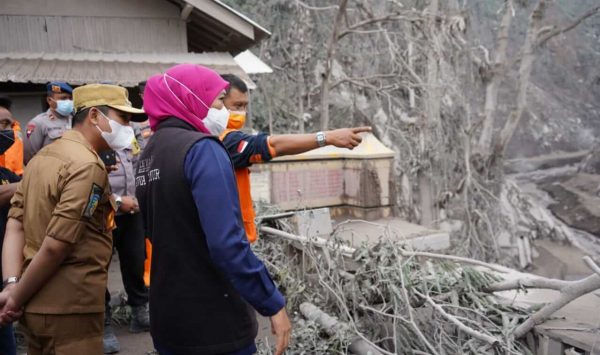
[252,227,528,354]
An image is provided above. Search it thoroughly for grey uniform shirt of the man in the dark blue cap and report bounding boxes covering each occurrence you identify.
[23,109,72,164]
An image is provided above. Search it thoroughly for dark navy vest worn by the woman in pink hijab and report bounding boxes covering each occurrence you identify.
[136,118,257,355]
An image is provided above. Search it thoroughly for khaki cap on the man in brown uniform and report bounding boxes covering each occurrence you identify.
[73,84,147,122]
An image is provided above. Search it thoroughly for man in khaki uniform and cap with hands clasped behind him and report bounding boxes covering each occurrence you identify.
[0,84,143,355]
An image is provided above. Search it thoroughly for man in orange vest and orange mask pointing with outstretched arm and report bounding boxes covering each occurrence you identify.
[219,74,371,243]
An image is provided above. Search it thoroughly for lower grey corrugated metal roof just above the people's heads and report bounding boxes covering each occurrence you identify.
[0,53,256,87]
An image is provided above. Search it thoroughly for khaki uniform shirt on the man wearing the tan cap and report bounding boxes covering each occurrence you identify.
[9,131,115,314]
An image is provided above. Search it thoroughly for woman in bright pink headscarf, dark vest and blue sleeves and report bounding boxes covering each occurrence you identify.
[136,64,291,355]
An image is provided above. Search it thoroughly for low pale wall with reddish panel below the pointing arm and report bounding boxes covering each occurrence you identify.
[250,156,395,219]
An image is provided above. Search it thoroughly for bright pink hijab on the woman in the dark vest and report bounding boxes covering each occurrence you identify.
[144,64,229,134]
